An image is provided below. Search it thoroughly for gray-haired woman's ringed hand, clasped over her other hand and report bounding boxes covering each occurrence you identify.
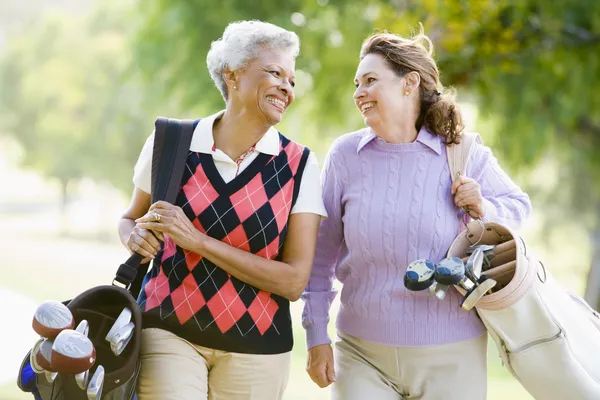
[135,201,205,251]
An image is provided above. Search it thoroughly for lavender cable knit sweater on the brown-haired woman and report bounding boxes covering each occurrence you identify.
[302,129,531,348]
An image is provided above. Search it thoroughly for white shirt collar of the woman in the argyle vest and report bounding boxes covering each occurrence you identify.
[190,110,280,156]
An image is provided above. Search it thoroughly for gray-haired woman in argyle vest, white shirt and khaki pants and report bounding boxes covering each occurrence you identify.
[119,21,326,400]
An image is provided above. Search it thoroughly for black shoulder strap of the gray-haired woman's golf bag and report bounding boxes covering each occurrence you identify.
[113,117,194,298]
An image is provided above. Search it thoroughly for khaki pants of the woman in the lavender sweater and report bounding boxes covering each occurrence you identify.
[332,333,487,400]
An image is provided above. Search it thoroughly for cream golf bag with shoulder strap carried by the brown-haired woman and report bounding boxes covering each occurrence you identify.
[448,134,600,400]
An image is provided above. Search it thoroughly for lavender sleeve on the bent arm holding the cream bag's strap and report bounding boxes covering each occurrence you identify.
[467,143,531,229]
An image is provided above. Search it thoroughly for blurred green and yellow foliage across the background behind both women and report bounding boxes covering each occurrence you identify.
[0,0,600,222]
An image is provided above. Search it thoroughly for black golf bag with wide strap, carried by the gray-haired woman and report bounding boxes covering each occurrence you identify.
[17,117,194,400]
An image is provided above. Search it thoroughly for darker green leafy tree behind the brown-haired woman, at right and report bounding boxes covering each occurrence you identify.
[398,0,600,309]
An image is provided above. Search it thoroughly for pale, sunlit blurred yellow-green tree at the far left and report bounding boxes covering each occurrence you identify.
[0,2,185,217]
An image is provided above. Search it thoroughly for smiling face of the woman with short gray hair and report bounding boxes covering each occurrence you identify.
[229,49,295,126]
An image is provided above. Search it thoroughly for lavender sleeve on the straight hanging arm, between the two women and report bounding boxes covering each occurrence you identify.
[302,144,344,349]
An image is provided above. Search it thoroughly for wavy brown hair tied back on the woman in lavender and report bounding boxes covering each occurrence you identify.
[360,26,464,144]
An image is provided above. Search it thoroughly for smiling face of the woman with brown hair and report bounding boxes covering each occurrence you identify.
[354,53,413,129]
